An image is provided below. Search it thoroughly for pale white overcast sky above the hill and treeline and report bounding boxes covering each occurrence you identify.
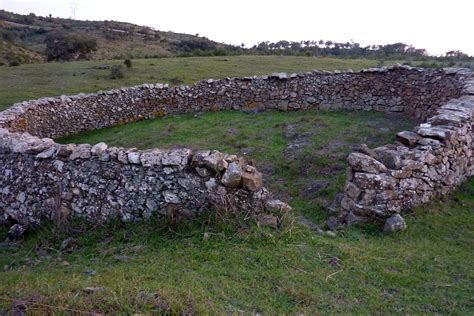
[0,0,474,55]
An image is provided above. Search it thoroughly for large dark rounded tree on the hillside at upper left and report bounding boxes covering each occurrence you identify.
[45,32,97,61]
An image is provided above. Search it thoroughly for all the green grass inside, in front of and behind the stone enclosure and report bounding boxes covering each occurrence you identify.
[0,57,474,315]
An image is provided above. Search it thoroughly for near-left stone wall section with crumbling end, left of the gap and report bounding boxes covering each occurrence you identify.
[0,128,289,229]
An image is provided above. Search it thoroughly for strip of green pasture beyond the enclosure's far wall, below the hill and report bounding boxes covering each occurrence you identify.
[0,56,386,110]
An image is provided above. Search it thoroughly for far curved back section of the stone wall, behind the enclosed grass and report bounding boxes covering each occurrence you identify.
[0,66,460,137]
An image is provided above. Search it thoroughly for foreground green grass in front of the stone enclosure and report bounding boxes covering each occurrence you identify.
[0,179,474,315]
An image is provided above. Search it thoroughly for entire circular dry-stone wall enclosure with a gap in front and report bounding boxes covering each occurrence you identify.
[0,65,474,235]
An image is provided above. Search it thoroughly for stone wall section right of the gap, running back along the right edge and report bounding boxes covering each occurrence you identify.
[340,70,474,230]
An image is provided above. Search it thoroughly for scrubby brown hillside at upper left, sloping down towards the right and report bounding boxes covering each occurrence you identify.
[0,10,231,63]
